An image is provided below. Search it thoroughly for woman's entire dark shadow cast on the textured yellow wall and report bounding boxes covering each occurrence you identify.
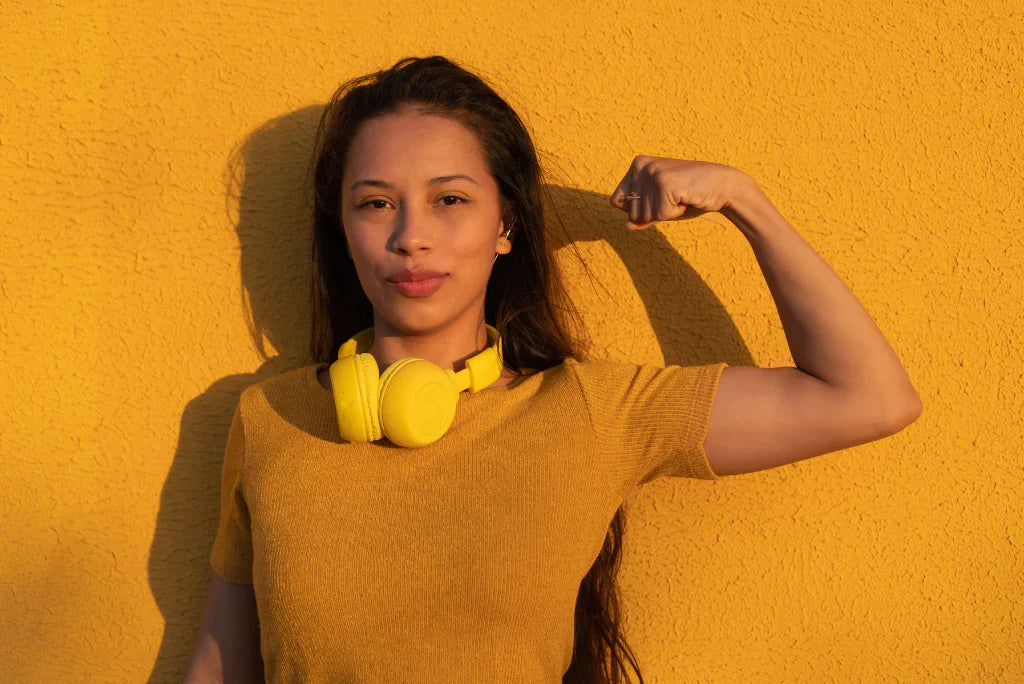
[148,105,754,683]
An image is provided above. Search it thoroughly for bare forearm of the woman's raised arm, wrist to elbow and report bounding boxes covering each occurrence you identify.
[721,176,921,416]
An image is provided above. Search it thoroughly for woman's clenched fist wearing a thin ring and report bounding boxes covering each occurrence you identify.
[611,155,754,230]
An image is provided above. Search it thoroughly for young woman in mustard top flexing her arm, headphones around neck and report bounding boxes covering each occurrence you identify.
[188,56,921,682]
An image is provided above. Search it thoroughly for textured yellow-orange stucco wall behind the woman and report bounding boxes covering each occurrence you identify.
[0,0,1024,682]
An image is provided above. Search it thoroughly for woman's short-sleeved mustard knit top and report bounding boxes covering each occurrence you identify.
[210,358,727,682]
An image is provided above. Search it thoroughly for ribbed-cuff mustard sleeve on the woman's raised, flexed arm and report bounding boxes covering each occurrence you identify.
[570,359,728,489]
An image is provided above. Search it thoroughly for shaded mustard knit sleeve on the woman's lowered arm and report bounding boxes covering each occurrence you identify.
[210,392,253,585]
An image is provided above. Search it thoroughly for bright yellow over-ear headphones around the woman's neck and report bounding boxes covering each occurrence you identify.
[330,325,503,446]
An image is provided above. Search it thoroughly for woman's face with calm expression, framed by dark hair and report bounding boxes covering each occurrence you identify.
[341,109,511,334]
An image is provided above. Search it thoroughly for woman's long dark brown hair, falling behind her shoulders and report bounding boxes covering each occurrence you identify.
[309,55,643,684]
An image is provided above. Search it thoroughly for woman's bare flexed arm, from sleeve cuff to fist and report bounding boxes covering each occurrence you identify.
[611,157,922,475]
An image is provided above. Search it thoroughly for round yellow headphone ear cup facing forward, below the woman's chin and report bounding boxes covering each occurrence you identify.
[379,358,459,446]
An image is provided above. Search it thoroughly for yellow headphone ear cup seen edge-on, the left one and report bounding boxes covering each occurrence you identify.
[330,354,381,441]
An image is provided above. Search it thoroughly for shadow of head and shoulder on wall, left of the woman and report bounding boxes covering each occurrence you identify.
[147,105,324,683]
